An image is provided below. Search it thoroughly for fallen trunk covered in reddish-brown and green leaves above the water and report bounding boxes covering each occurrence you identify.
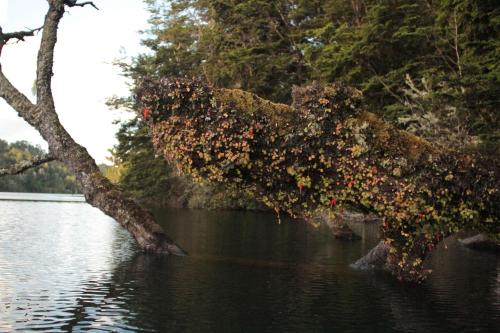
[136,79,500,282]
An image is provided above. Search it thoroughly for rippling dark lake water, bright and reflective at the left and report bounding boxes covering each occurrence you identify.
[0,193,500,332]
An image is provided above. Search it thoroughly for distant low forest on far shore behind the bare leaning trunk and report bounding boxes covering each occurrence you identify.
[0,139,79,193]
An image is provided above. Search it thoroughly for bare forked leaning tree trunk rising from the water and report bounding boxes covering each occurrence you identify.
[0,0,186,255]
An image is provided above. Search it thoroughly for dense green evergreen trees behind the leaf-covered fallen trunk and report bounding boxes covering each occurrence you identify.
[107,0,500,206]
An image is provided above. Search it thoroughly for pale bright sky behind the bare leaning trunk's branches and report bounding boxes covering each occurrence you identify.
[0,0,148,163]
